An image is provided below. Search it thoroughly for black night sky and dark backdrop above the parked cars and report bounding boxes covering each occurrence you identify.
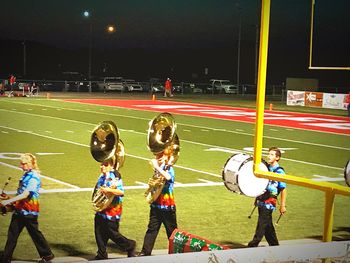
[0,0,350,86]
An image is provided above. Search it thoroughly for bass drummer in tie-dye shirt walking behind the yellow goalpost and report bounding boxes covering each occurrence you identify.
[248,147,287,247]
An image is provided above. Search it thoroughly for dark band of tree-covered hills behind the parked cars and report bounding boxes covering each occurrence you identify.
[0,39,350,87]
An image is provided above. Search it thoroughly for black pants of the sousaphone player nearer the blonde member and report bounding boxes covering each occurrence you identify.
[95,215,136,259]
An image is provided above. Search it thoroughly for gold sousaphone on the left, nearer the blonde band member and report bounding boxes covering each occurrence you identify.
[90,121,125,212]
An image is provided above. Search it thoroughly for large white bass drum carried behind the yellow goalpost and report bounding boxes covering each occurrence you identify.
[222,153,269,197]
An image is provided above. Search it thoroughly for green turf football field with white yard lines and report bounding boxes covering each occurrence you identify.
[0,97,350,259]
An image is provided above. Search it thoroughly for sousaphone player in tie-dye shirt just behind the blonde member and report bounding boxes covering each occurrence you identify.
[94,159,136,260]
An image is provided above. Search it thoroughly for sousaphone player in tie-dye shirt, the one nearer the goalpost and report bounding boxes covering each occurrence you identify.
[139,149,177,256]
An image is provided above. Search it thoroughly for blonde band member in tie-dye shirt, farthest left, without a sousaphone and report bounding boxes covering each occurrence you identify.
[1,153,54,263]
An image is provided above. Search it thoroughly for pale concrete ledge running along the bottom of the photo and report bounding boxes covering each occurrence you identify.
[12,242,350,263]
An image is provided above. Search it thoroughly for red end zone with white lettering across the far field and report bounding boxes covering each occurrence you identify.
[67,99,350,135]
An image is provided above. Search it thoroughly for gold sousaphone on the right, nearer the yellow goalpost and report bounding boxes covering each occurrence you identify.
[145,112,180,204]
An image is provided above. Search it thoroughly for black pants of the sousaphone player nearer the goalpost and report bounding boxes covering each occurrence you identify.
[141,207,177,255]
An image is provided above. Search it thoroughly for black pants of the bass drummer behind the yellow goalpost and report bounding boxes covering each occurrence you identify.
[248,207,279,247]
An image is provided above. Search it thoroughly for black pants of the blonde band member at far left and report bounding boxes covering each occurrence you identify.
[2,214,52,263]
